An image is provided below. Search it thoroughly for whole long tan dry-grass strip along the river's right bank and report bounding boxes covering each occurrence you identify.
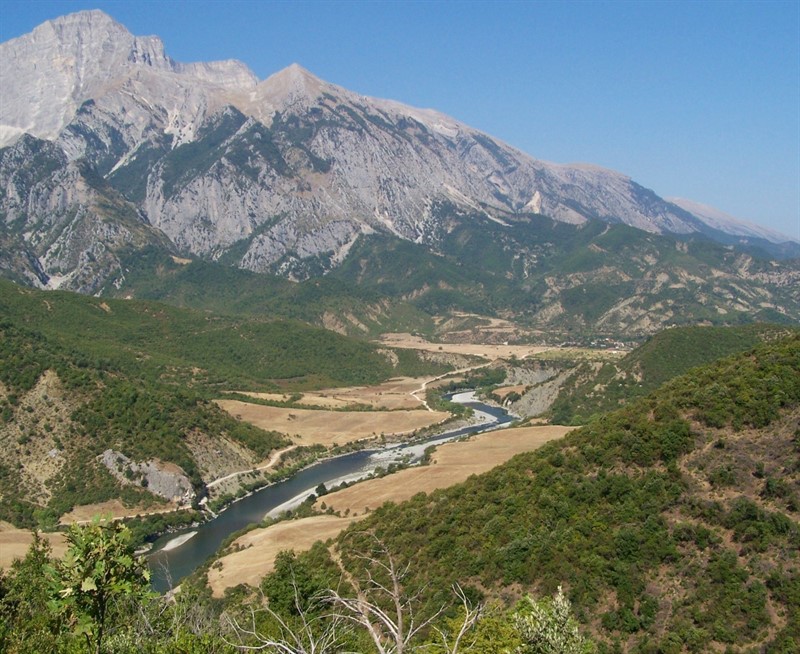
[208,426,573,597]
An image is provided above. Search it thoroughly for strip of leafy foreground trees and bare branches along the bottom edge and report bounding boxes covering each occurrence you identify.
[0,523,595,654]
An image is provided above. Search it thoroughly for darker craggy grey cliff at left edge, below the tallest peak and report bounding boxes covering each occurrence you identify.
[0,135,168,294]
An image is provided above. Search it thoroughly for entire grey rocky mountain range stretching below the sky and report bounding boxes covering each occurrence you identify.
[0,11,800,293]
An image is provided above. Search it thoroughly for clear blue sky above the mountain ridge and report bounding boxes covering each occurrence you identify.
[0,0,800,238]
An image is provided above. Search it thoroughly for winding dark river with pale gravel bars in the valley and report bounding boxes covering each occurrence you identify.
[149,392,513,592]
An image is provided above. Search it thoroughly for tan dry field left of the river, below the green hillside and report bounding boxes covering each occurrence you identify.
[217,400,449,446]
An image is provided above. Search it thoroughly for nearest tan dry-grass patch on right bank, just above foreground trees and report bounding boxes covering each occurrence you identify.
[208,515,359,597]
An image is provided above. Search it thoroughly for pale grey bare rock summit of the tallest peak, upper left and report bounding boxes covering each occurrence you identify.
[0,10,258,153]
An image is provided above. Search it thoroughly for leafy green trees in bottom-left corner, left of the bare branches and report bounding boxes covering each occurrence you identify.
[0,523,236,654]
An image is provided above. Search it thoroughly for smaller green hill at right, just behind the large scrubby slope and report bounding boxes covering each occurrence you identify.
[550,324,797,425]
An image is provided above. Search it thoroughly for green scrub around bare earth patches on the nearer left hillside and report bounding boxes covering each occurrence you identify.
[0,320,287,526]
